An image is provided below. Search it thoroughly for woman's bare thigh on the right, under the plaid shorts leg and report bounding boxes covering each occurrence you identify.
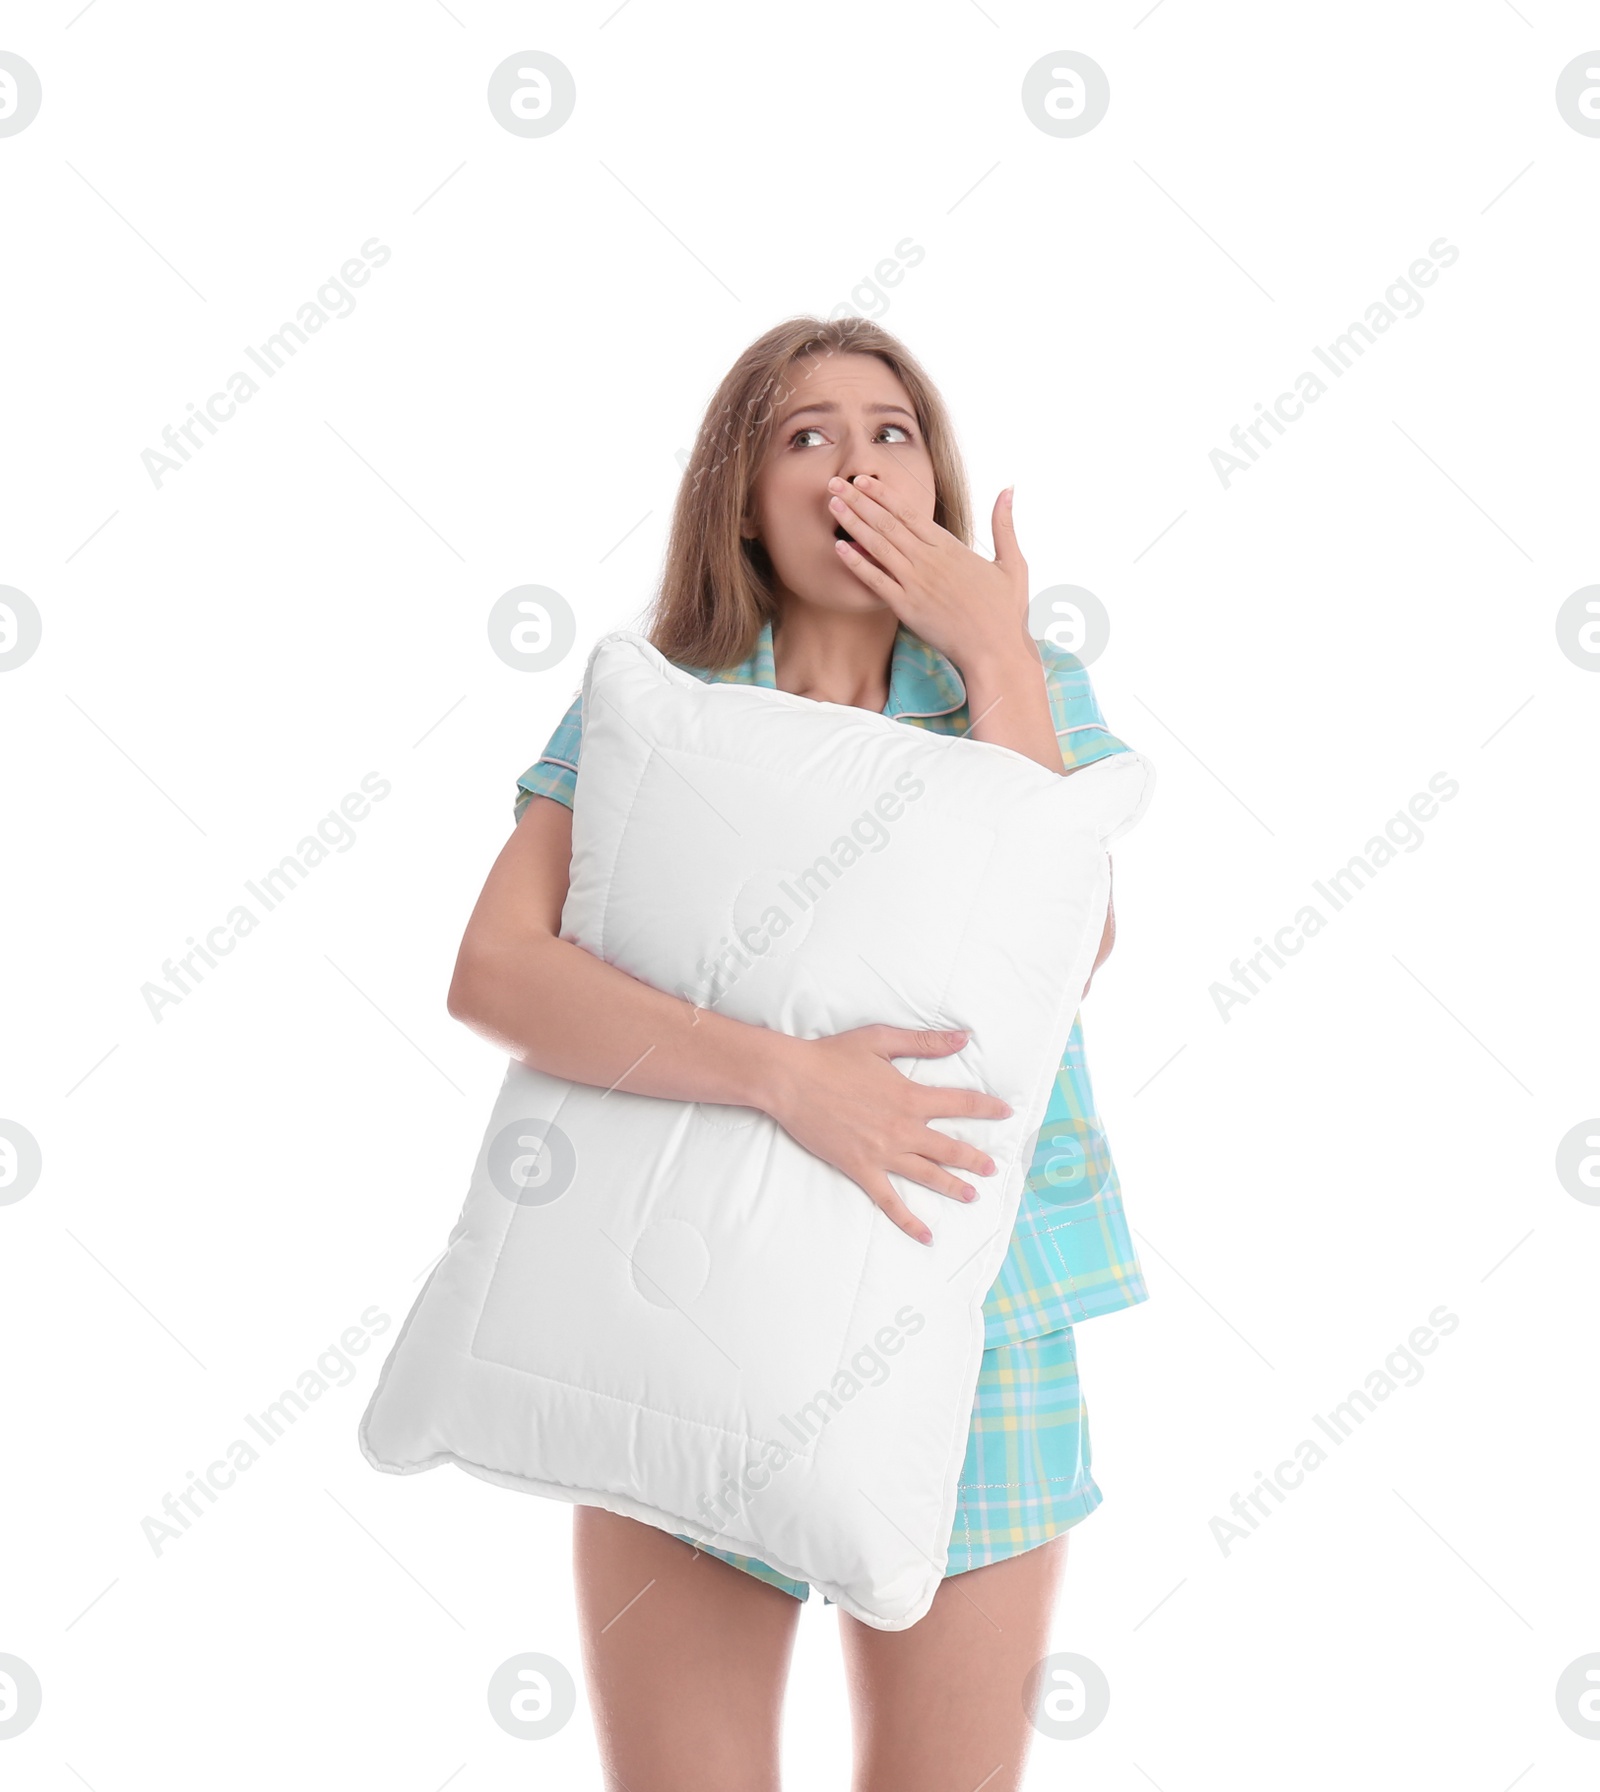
[839,1532,1068,1792]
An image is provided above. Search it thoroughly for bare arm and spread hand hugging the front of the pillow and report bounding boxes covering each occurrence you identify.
[446,796,1011,1244]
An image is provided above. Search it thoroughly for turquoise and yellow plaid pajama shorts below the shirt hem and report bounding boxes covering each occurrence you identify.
[674,1326,1104,1606]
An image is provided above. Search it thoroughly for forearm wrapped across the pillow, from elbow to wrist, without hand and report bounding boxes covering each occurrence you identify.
[448,930,792,1111]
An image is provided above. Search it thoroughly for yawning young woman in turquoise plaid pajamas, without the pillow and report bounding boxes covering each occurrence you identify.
[450,317,1145,1792]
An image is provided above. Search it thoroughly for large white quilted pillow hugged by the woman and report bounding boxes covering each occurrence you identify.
[360,631,1154,1631]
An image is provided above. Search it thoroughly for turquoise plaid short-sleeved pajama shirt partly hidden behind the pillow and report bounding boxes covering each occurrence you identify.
[516,622,1148,1349]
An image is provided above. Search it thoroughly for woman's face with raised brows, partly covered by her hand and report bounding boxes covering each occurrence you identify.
[742,355,933,611]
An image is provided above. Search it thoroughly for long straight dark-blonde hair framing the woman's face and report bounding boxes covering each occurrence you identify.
[643,317,973,670]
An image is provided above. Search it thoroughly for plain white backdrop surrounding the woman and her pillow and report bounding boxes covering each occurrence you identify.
[0,0,1600,1792]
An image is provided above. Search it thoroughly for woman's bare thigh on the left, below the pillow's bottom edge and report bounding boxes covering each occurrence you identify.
[572,1505,799,1792]
